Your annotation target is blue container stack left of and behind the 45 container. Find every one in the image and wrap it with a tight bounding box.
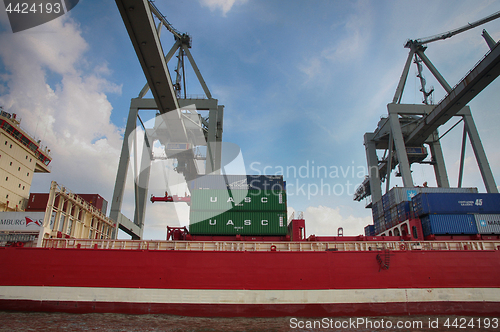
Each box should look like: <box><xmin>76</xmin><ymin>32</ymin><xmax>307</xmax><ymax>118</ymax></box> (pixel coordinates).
<box><xmin>372</xmin><ymin>187</ymin><xmax>477</xmax><ymax>234</ymax></box>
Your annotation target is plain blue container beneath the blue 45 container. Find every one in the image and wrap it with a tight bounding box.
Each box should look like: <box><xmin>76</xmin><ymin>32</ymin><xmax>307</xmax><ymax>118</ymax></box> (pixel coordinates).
<box><xmin>421</xmin><ymin>214</ymin><xmax>478</xmax><ymax>236</ymax></box>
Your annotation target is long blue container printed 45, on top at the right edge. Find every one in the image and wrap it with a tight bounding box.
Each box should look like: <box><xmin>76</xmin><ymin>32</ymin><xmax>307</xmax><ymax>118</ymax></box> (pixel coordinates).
<box><xmin>412</xmin><ymin>193</ymin><xmax>500</xmax><ymax>216</ymax></box>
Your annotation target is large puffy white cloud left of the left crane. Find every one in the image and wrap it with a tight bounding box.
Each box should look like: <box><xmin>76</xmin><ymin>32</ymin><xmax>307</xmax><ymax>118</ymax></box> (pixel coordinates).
<box><xmin>0</xmin><ymin>15</ymin><xmax>121</xmax><ymax>197</ymax></box>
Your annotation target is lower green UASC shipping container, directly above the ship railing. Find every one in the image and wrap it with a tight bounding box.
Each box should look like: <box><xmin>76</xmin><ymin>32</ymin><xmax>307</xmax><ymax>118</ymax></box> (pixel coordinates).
<box><xmin>189</xmin><ymin>210</ymin><xmax>288</xmax><ymax>235</ymax></box>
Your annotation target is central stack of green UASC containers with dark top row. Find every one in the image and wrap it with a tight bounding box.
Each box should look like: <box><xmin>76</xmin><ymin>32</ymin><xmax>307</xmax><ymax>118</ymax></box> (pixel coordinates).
<box><xmin>189</xmin><ymin>175</ymin><xmax>288</xmax><ymax>236</ymax></box>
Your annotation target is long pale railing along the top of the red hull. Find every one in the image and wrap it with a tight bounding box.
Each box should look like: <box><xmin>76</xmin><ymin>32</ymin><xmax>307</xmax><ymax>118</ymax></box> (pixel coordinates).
<box><xmin>42</xmin><ymin>238</ymin><xmax>500</xmax><ymax>252</ymax></box>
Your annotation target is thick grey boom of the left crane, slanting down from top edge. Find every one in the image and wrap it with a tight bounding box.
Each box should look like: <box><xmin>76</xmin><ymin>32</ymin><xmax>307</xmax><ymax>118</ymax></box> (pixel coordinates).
<box><xmin>116</xmin><ymin>0</ymin><xmax>179</xmax><ymax>113</ymax></box>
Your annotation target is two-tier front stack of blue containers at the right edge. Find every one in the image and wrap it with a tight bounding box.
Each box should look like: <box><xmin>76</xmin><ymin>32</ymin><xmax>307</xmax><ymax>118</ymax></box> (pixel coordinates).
<box><xmin>412</xmin><ymin>193</ymin><xmax>500</xmax><ymax>236</ymax></box>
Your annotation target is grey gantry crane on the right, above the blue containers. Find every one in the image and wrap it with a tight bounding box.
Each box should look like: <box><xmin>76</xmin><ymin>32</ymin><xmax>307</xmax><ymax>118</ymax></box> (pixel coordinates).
<box><xmin>354</xmin><ymin>12</ymin><xmax>500</xmax><ymax>207</ymax></box>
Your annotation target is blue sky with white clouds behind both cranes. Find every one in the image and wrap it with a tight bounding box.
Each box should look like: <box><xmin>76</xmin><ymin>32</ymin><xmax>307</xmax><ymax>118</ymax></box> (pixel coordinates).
<box><xmin>0</xmin><ymin>0</ymin><xmax>500</xmax><ymax>239</ymax></box>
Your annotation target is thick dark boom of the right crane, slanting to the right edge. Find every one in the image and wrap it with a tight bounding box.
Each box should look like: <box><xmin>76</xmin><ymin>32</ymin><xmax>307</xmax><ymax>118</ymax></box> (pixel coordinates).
<box><xmin>406</xmin><ymin>45</ymin><xmax>500</xmax><ymax>144</ymax></box>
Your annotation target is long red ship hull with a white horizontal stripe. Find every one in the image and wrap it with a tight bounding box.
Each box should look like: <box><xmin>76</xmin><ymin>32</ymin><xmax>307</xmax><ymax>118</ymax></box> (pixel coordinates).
<box><xmin>0</xmin><ymin>248</ymin><xmax>500</xmax><ymax>317</ymax></box>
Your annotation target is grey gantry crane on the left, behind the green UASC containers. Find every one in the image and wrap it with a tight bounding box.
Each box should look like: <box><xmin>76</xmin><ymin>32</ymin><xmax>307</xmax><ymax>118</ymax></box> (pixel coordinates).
<box><xmin>110</xmin><ymin>0</ymin><xmax>224</xmax><ymax>239</ymax></box>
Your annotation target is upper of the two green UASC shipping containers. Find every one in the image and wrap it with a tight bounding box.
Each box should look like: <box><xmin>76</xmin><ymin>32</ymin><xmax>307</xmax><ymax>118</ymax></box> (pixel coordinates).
<box><xmin>191</xmin><ymin>189</ymin><xmax>286</xmax><ymax>212</ymax></box>
